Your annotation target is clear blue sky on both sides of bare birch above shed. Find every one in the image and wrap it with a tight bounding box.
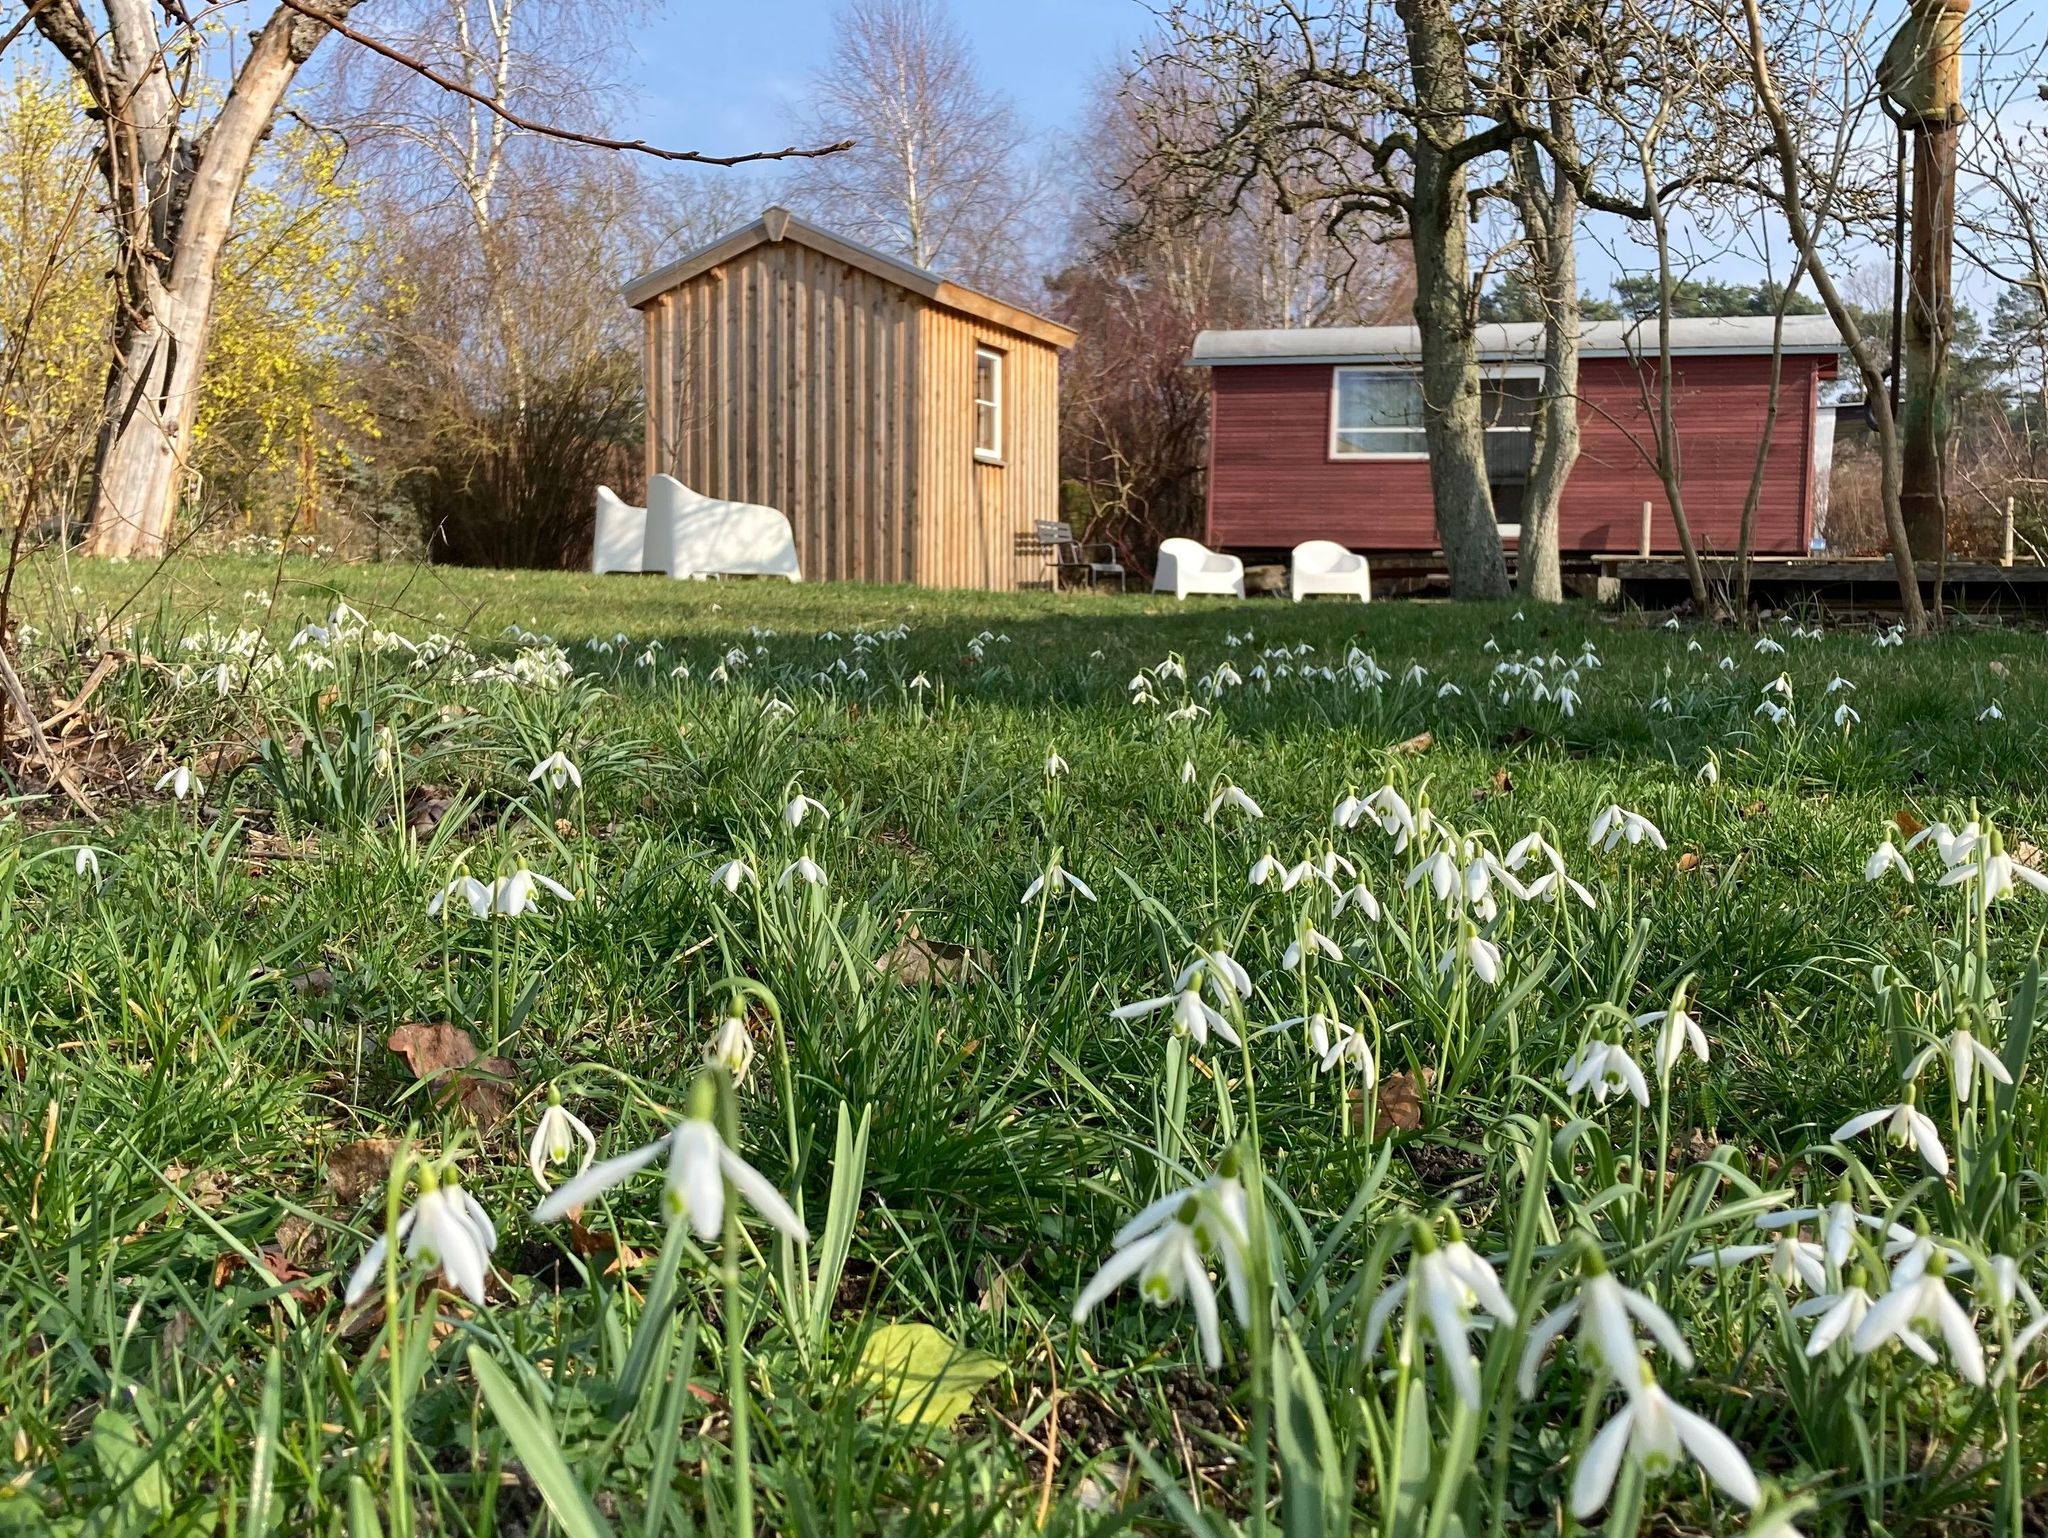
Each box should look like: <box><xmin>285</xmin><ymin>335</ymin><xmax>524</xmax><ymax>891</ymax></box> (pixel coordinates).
<box><xmin>631</xmin><ymin>0</ymin><xmax>1149</xmax><ymax>165</ymax></box>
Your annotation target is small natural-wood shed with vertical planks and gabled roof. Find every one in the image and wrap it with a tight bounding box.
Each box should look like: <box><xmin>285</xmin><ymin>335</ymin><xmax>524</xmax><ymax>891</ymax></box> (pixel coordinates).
<box><xmin>627</xmin><ymin>209</ymin><xmax>1075</xmax><ymax>588</ymax></box>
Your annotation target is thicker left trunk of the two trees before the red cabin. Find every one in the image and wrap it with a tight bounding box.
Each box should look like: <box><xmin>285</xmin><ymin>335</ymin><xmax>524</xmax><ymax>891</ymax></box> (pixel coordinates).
<box><xmin>1399</xmin><ymin>0</ymin><xmax>1507</xmax><ymax>598</ymax></box>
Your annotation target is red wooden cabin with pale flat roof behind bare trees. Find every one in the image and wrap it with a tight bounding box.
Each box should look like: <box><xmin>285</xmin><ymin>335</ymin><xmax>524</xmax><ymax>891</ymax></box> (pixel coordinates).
<box><xmin>1190</xmin><ymin>315</ymin><xmax>1841</xmax><ymax>557</ymax></box>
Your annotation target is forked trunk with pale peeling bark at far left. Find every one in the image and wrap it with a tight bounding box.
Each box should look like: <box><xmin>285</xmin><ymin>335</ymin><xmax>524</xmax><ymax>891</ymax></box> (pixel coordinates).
<box><xmin>35</xmin><ymin>0</ymin><xmax>356</xmax><ymax>557</ymax></box>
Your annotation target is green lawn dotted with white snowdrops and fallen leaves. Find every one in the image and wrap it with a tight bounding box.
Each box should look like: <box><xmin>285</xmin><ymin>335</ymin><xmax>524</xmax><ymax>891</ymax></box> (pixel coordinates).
<box><xmin>0</xmin><ymin>559</ymin><xmax>2048</xmax><ymax>1538</ymax></box>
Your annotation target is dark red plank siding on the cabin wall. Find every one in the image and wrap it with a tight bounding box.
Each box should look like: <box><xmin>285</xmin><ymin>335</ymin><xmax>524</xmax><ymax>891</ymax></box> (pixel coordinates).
<box><xmin>1208</xmin><ymin>354</ymin><xmax>1833</xmax><ymax>555</ymax></box>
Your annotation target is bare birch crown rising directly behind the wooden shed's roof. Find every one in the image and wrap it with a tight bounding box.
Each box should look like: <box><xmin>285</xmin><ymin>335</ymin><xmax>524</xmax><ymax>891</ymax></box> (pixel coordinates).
<box><xmin>793</xmin><ymin>0</ymin><xmax>1040</xmax><ymax>295</ymax></box>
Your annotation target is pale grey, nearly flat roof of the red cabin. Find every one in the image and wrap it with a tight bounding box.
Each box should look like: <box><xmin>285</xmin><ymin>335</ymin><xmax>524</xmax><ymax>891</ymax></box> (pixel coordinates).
<box><xmin>1188</xmin><ymin>315</ymin><xmax>1841</xmax><ymax>367</ymax></box>
